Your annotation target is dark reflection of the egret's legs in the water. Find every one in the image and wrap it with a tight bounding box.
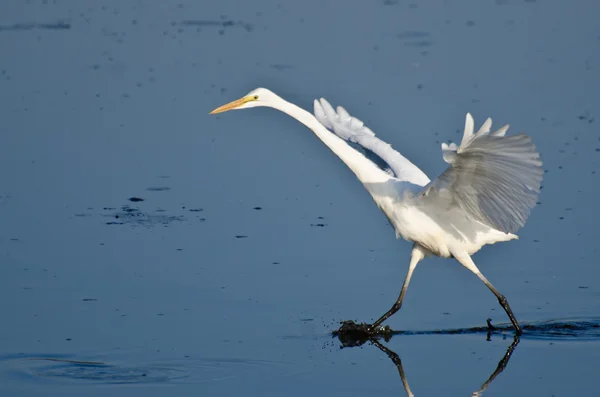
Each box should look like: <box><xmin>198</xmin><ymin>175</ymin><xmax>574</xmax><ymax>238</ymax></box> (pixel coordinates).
<box><xmin>337</xmin><ymin>330</ymin><xmax>519</xmax><ymax>397</ymax></box>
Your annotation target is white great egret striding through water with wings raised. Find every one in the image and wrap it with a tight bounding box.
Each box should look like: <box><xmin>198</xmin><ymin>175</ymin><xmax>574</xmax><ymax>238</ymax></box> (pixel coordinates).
<box><xmin>210</xmin><ymin>88</ymin><xmax>543</xmax><ymax>334</ymax></box>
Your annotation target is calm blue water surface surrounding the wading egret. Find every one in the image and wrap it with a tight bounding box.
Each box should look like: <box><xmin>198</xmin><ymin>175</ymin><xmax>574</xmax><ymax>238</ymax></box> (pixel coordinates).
<box><xmin>0</xmin><ymin>0</ymin><xmax>600</xmax><ymax>396</ymax></box>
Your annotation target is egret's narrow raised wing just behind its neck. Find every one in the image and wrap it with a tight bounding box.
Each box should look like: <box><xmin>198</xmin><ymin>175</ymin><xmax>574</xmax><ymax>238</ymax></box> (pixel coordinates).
<box><xmin>314</xmin><ymin>98</ymin><xmax>429</xmax><ymax>186</ymax></box>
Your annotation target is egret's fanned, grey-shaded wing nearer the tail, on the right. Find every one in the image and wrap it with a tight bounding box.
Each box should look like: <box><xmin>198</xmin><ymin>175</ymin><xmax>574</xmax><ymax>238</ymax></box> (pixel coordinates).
<box><xmin>421</xmin><ymin>113</ymin><xmax>543</xmax><ymax>233</ymax></box>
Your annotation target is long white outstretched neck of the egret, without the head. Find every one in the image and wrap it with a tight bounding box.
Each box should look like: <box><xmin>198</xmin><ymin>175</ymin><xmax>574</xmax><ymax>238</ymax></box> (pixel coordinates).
<box><xmin>269</xmin><ymin>98</ymin><xmax>391</xmax><ymax>184</ymax></box>
